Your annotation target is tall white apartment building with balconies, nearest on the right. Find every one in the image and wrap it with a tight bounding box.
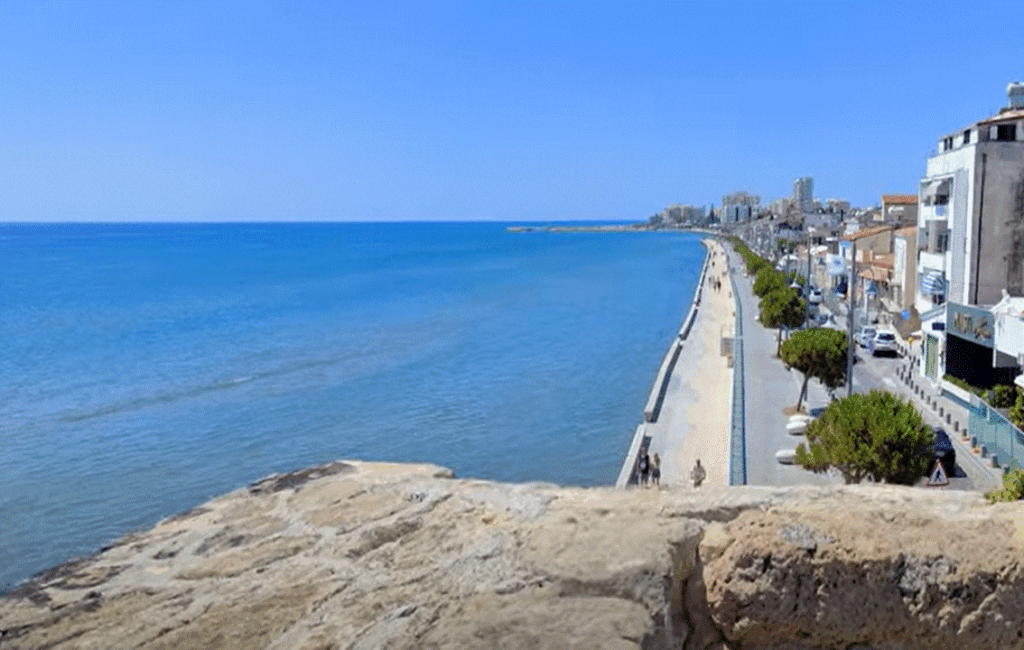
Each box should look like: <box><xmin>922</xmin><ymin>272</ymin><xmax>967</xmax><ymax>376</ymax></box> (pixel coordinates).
<box><xmin>914</xmin><ymin>84</ymin><xmax>1024</xmax><ymax>313</ymax></box>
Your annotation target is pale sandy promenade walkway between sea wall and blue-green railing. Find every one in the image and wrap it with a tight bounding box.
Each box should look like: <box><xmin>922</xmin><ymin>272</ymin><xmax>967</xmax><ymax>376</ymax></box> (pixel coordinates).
<box><xmin>630</xmin><ymin>239</ymin><xmax>735</xmax><ymax>486</ymax></box>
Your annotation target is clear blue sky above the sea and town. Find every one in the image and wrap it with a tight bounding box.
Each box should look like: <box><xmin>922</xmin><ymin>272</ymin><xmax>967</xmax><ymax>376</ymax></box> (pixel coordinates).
<box><xmin>0</xmin><ymin>0</ymin><xmax>1024</xmax><ymax>221</ymax></box>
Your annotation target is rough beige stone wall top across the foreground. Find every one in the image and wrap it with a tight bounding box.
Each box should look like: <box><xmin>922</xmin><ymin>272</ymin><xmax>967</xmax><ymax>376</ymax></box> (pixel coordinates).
<box><xmin>0</xmin><ymin>462</ymin><xmax>1024</xmax><ymax>650</ymax></box>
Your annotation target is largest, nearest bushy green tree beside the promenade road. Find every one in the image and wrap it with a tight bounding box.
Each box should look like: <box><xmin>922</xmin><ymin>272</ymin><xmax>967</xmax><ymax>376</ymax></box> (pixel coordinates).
<box><xmin>797</xmin><ymin>390</ymin><xmax>935</xmax><ymax>485</ymax></box>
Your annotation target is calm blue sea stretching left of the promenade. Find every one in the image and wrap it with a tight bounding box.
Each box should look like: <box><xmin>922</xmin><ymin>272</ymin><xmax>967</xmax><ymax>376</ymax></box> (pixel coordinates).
<box><xmin>0</xmin><ymin>222</ymin><xmax>705</xmax><ymax>588</ymax></box>
